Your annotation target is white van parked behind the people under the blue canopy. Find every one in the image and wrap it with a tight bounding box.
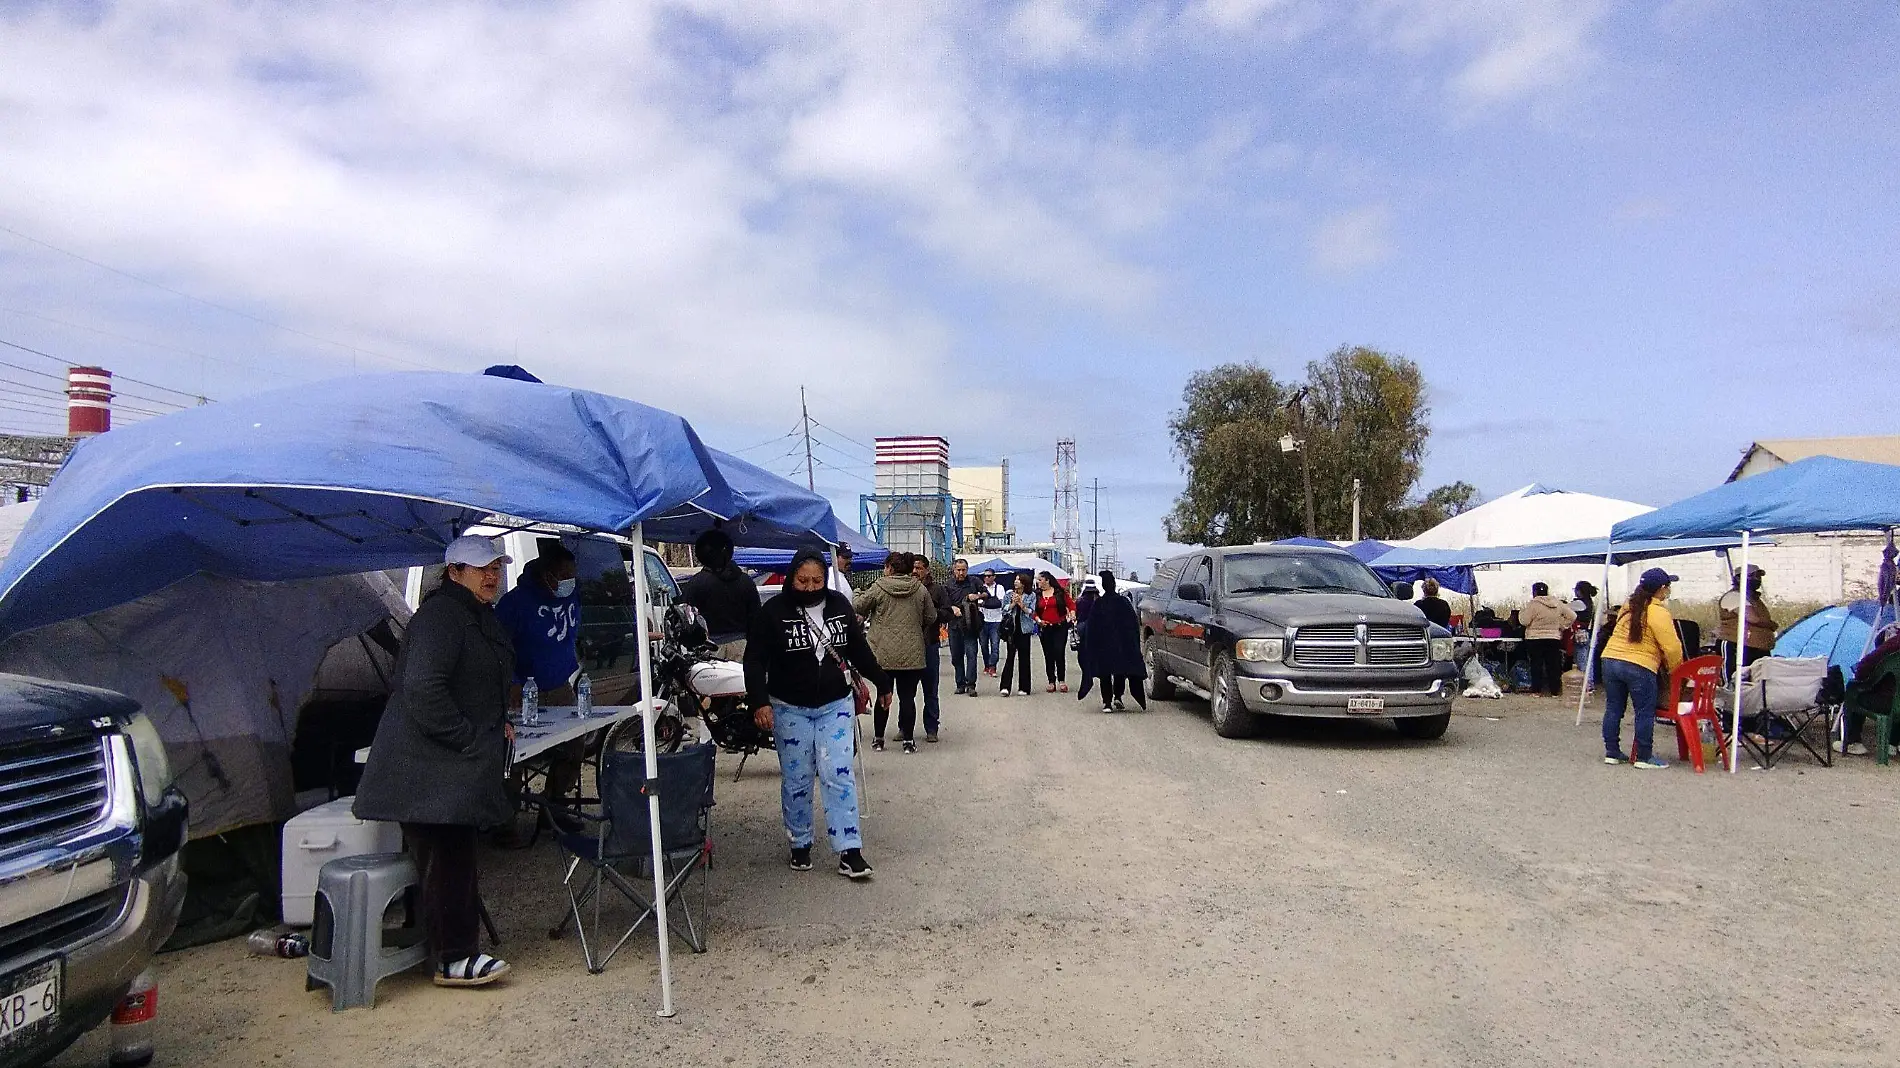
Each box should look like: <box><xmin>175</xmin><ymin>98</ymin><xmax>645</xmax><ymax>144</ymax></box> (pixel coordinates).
<box><xmin>403</xmin><ymin>526</ymin><xmax>680</xmax><ymax>705</ymax></box>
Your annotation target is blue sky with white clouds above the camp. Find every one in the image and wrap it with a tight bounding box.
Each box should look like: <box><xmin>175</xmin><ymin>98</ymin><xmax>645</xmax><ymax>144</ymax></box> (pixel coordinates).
<box><xmin>0</xmin><ymin>0</ymin><xmax>1900</xmax><ymax>574</ymax></box>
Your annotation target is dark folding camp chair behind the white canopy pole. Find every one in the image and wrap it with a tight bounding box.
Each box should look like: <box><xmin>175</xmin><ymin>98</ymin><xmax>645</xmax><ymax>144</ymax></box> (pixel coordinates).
<box><xmin>547</xmin><ymin>743</ymin><xmax>718</xmax><ymax>975</ymax></box>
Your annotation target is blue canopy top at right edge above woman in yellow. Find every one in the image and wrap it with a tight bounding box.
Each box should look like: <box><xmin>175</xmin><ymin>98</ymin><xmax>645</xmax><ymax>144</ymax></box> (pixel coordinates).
<box><xmin>1609</xmin><ymin>456</ymin><xmax>1900</xmax><ymax>544</ymax></box>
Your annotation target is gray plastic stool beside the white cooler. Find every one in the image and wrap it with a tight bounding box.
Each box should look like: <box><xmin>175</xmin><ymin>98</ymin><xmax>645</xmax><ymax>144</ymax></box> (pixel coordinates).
<box><xmin>304</xmin><ymin>853</ymin><xmax>429</xmax><ymax>1013</ymax></box>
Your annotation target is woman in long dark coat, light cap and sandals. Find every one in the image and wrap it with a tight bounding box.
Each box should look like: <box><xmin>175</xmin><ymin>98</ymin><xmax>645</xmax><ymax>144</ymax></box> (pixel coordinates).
<box><xmin>353</xmin><ymin>534</ymin><xmax>515</xmax><ymax>986</ymax></box>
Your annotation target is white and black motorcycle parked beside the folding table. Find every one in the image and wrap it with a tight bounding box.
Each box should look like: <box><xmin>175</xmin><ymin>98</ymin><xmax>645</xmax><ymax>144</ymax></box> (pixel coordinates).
<box><xmin>602</xmin><ymin>604</ymin><xmax>775</xmax><ymax>779</ymax></box>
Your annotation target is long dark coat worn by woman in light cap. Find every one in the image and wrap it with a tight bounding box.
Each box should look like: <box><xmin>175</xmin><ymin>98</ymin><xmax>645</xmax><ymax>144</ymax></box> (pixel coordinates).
<box><xmin>352</xmin><ymin>583</ymin><xmax>515</xmax><ymax>827</ymax></box>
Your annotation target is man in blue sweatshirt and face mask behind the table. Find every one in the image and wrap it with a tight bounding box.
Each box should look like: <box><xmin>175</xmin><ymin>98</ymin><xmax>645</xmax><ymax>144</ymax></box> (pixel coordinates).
<box><xmin>494</xmin><ymin>540</ymin><xmax>587</xmax><ymax>824</ymax></box>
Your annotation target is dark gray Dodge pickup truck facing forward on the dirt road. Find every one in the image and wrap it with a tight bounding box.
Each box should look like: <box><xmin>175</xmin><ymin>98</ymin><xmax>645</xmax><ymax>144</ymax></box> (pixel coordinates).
<box><xmin>1140</xmin><ymin>545</ymin><xmax>1457</xmax><ymax>739</ymax></box>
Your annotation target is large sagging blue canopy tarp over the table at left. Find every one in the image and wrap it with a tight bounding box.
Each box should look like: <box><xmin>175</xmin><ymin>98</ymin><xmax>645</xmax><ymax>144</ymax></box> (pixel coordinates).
<box><xmin>0</xmin><ymin>372</ymin><xmax>830</xmax><ymax>635</ymax></box>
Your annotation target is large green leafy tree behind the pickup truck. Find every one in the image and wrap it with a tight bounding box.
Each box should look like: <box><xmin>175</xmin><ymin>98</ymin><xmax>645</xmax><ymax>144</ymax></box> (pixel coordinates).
<box><xmin>1165</xmin><ymin>346</ymin><xmax>1476</xmax><ymax>545</ymax></box>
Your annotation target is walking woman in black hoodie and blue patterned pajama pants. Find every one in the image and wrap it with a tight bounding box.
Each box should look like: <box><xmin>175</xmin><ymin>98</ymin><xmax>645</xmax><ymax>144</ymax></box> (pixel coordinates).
<box><xmin>745</xmin><ymin>549</ymin><xmax>891</xmax><ymax>880</ymax></box>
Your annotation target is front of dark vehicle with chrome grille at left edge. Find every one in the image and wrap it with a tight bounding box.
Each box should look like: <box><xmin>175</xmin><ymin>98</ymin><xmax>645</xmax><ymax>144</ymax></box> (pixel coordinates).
<box><xmin>0</xmin><ymin>675</ymin><xmax>184</xmax><ymax>1066</ymax></box>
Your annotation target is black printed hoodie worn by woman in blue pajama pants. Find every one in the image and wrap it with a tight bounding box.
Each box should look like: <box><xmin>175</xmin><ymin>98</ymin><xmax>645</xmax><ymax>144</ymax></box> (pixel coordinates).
<box><xmin>745</xmin><ymin>589</ymin><xmax>891</xmax><ymax>709</ymax></box>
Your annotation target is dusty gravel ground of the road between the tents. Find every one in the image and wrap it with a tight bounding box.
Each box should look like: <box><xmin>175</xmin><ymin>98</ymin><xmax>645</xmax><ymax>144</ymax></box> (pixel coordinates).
<box><xmin>59</xmin><ymin>686</ymin><xmax>1900</xmax><ymax>1068</ymax></box>
